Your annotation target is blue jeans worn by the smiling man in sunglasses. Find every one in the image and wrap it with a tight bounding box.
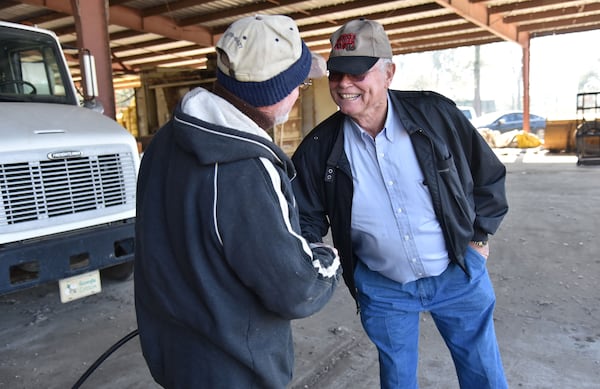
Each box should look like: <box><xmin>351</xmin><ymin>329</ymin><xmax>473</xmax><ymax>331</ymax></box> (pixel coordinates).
<box><xmin>354</xmin><ymin>247</ymin><xmax>508</xmax><ymax>389</ymax></box>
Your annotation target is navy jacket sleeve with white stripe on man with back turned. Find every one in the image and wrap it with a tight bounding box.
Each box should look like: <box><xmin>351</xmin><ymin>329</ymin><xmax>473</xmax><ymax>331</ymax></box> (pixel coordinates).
<box><xmin>215</xmin><ymin>158</ymin><xmax>341</xmax><ymax>319</ymax></box>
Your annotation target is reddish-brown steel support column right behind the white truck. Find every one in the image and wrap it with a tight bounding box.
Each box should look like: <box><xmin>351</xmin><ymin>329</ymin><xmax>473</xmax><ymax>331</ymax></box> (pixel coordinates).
<box><xmin>71</xmin><ymin>0</ymin><xmax>116</xmax><ymax>119</ymax></box>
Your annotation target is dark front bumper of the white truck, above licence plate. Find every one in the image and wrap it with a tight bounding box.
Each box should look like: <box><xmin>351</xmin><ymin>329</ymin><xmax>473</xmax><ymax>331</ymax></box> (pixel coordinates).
<box><xmin>0</xmin><ymin>218</ymin><xmax>135</xmax><ymax>295</ymax></box>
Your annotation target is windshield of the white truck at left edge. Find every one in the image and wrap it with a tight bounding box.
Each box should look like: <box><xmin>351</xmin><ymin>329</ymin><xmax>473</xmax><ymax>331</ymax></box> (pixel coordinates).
<box><xmin>0</xmin><ymin>27</ymin><xmax>76</xmax><ymax>104</ymax></box>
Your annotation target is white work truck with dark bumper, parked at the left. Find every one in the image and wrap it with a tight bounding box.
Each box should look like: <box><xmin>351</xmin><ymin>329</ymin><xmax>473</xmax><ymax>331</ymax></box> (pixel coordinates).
<box><xmin>0</xmin><ymin>22</ymin><xmax>139</xmax><ymax>302</ymax></box>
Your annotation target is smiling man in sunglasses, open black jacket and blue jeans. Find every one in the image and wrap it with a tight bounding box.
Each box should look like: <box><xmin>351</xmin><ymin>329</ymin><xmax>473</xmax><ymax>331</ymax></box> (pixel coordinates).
<box><xmin>292</xmin><ymin>19</ymin><xmax>508</xmax><ymax>389</ymax></box>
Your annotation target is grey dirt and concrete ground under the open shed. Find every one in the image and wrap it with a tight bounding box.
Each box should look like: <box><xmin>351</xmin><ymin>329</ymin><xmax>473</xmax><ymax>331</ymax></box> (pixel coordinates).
<box><xmin>0</xmin><ymin>149</ymin><xmax>600</xmax><ymax>389</ymax></box>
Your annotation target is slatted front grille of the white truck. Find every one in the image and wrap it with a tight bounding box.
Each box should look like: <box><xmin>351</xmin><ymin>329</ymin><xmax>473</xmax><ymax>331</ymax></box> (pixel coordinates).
<box><xmin>0</xmin><ymin>153</ymin><xmax>136</xmax><ymax>226</ymax></box>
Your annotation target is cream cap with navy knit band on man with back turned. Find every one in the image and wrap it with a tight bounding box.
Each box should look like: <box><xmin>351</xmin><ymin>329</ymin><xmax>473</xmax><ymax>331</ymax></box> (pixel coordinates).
<box><xmin>216</xmin><ymin>15</ymin><xmax>312</xmax><ymax>107</ymax></box>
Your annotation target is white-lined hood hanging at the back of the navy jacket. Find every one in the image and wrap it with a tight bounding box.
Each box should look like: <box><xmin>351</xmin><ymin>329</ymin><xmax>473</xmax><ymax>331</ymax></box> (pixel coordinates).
<box><xmin>173</xmin><ymin>88</ymin><xmax>295</xmax><ymax>178</ymax></box>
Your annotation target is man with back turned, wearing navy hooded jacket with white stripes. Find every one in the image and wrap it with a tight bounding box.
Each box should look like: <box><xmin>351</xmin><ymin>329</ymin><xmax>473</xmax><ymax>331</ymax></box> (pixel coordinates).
<box><xmin>134</xmin><ymin>15</ymin><xmax>341</xmax><ymax>389</ymax></box>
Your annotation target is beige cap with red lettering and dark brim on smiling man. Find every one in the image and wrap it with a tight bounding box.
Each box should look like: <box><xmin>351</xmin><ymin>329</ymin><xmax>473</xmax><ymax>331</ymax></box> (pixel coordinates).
<box><xmin>327</xmin><ymin>18</ymin><xmax>393</xmax><ymax>74</ymax></box>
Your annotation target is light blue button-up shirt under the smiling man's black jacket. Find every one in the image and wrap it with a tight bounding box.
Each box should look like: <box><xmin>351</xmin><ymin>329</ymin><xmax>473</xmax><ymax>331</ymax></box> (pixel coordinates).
<box><xmin>344</xmin><ymin>98</ymin><xmax>449</xmax><ymax>284</ymax></box>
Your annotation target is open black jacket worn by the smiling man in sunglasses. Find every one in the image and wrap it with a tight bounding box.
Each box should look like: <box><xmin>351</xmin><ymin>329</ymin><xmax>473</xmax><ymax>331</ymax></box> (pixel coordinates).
<box><xmin>292</xmin><ymin>90</ymin><xmax>508</xmax><ymax>297</ymax></box>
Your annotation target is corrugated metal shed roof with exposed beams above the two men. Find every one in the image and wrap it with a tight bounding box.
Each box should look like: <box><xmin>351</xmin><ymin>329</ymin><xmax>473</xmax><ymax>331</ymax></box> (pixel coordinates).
<box><xmin>0</xmin><ymin>0</ymin><xmax>600</xmax><ymax>87</ymax></box>
